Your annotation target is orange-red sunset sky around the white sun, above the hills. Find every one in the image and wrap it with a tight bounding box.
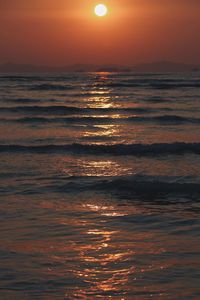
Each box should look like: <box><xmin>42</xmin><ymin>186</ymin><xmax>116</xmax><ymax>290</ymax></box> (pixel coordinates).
<box><xmin>0</xmin><ymin>0</ymin><xmax>200</xmax><ymax>66</ymax></box>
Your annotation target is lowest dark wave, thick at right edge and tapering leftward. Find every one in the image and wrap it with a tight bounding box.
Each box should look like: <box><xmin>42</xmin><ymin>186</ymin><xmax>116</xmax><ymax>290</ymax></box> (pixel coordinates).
<box><xmin>56</xmin><ymin>175</ymin><xmax>200</xmax><ymax>196</ymax></box>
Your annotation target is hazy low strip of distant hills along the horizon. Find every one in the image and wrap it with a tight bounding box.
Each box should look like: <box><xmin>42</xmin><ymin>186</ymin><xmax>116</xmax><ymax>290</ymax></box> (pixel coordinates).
<box><xmin>0</xmin><ymin>61</ymin><xmax>200</xmax><ymax>73</ymax></box>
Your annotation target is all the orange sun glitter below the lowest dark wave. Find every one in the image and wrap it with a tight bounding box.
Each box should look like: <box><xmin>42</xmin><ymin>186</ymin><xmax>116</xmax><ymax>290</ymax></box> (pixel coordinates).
<box><xmin>66</xmin><ymin>203</ymin><xmax>167</xmax><ymax>299</ymax></box>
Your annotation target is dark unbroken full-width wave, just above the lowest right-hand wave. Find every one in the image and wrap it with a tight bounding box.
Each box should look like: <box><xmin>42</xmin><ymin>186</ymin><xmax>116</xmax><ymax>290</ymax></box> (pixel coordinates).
<box><xmin>0</xmin><ymin>142</ymin><xmax>200</xmax><ymax>156</ymax></box>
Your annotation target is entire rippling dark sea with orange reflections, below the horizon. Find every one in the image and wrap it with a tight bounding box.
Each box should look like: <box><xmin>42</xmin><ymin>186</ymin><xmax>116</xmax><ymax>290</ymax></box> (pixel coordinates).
<box><xmin>0</xmin><ymin>72</ymin><xmax>200</xmax><ymax>300</ymax></box>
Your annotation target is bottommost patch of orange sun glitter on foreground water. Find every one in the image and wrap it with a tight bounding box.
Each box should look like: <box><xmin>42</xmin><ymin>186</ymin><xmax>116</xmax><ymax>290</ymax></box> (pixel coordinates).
<box><xmin>70</xmin><ymin>224</ymin><xmax>134</xmax><ymax>297</ymax></box>
